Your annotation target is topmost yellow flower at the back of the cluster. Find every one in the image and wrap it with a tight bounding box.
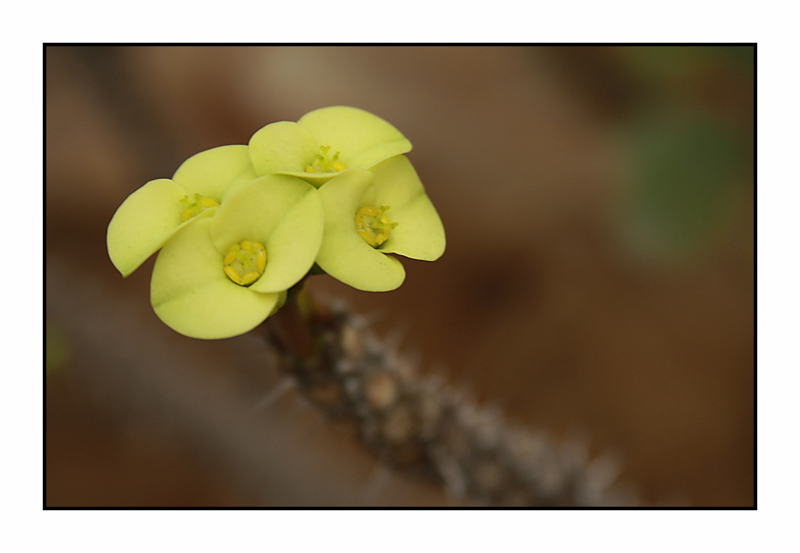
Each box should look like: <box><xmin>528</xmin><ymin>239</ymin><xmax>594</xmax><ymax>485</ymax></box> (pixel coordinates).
<box><xmin>249</xmin><ymin>106</ymin><xmax>411</xmax><ymax>187</ymax></box>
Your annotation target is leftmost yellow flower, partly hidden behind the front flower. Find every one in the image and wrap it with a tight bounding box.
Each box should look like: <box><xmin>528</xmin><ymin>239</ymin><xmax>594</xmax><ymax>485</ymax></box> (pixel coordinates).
<box><xmin>106</xmin><ymin>145</ymin><xmax>258</xmax><ymax>276</ymax></box>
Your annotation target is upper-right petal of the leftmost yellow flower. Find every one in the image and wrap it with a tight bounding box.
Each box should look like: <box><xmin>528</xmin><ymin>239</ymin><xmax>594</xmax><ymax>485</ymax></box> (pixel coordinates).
<box><xmin>172</xmin><ymin>145</ymin><xmax>258</xmax><ymax>203</ymax></box>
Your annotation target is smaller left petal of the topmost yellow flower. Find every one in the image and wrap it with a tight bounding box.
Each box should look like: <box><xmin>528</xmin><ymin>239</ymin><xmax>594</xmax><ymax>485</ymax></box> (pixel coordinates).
<box><xmin>249</xmin><ymin>121</ymin><xmax>320</xmax><ymax>178</ymax></box>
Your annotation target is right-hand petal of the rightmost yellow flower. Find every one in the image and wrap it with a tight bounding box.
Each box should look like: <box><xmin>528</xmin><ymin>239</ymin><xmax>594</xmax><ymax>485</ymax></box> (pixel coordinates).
<box><xmin>364</xmin><ymin>156</ymin><xmax>445</xmax><ymax>261</ymax></box>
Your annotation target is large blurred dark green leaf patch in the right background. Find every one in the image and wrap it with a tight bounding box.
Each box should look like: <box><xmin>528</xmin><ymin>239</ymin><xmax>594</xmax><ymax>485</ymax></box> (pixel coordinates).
<box><xmin>622</xmin><ymin>116</ymin><xmax>747</xmax><ymax>259</ymax></box>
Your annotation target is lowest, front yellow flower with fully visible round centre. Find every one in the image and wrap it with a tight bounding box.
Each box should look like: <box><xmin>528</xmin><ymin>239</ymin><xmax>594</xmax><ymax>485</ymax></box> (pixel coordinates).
<box><xmin>150</xmin><ymin>175</ymin><xmax>323</xmax><ymax>339</ymax></box>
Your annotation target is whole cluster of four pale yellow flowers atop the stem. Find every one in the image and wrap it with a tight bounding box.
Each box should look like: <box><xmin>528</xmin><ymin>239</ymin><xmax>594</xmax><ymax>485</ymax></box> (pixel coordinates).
<box><xmin>107</xmin><ymin>106</ymin><xmax>445</xmax><ymax>339</ymax></box>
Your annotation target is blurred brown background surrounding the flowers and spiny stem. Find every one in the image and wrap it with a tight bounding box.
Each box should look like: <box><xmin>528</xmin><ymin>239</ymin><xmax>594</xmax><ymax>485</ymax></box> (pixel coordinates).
<box><xmin>45</xmin><ymin>46</ymin><xmax>755</xmax><ymax>506</ymax></box>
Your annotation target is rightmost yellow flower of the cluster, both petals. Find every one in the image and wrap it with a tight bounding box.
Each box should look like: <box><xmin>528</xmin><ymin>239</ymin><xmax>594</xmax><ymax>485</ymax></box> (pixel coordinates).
<box><xmin>317</xmin><ymin>155</ymin><xmax>445</xmax><ymax>292</ymax></box>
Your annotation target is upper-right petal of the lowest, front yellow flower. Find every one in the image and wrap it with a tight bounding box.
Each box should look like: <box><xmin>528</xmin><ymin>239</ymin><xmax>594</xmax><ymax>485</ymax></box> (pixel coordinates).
<box><xmin>211</xmin><ymin>175</ymin><xmax>323</xmax><ymax>292</ymax></box>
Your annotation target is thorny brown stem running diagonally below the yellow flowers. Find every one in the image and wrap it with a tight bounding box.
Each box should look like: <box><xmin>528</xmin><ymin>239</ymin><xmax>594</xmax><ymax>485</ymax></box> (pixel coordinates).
<box><xmin>267</xmin><ymin>291</ymin><xmax>634</xmax><ymax>506</ymax></box>
